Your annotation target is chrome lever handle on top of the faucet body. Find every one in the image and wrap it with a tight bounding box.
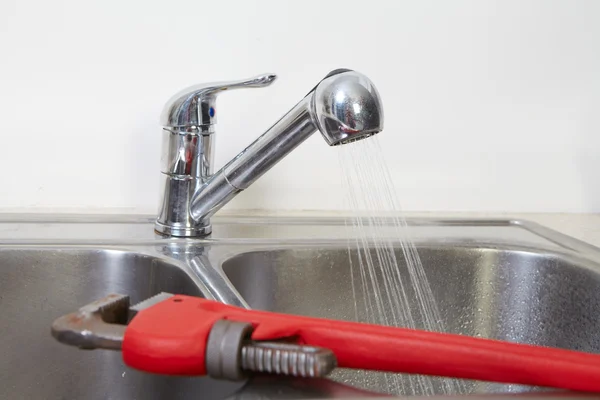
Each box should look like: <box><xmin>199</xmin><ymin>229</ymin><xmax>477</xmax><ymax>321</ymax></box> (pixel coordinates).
<box><xmin>160</xmin><ymin>74</ymin><xmax>277</xmax><ymax>129</ymax></box>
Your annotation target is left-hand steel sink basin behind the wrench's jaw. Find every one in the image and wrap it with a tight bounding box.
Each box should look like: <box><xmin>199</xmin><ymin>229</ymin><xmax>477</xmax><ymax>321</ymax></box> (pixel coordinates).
<box><xmin>0</xmin><ymin>247</ymin><xmax>240</xmax><ymax>399</ymax></box>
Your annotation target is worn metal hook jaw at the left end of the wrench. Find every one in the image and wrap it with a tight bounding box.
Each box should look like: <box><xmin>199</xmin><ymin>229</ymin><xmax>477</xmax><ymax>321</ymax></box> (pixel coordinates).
<box><xmin>52</xmin><ymin>294</ymin><xmax>129</xmax><ymax>350</ymax></box>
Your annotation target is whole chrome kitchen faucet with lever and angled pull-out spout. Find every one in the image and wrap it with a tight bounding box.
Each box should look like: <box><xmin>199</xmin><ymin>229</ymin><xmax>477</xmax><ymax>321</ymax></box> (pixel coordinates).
<box><xmin>155</xmin><ymin>69</ymin><xmax>383</xmax><ymax>237</ymax></box>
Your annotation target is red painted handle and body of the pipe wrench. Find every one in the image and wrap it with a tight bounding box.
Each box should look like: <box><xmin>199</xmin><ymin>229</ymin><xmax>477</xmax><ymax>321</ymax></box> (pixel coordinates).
<box><xmin>123</xmin><ymin>295</ymin><xmax>600</xmax><ymax>392</ymax></box>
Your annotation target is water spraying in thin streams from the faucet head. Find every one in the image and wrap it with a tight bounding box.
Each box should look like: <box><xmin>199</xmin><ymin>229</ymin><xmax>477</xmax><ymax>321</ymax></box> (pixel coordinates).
<box><xmin>338</xmin><ymin>136</ymin><xmax>465</xmax><ymax>395</ymax></box>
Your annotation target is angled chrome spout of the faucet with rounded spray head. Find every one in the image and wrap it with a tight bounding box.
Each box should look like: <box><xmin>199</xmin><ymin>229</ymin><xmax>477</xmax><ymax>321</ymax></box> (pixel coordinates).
<box><xmin>190</xmin><ymin>70</ymin><xmax>383</xmax><ymax>220</ymax></box>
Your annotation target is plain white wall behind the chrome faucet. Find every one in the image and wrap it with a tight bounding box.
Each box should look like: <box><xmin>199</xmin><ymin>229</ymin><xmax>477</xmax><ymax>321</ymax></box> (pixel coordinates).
<box><xmin>0</xmin><ymin>0</ymin><xmax>600</xmax><ymax>213</ymax></box>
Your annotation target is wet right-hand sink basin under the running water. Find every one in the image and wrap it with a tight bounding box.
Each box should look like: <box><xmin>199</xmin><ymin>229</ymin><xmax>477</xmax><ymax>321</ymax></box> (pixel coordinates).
<box><xmin>222</xmin><ymin>244</ymin><xmax>600</xmax><ymax>394</ymax></box>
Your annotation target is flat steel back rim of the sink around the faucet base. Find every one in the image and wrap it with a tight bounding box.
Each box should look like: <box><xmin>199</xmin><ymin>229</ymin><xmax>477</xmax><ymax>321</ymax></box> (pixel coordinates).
<box><xmin>0</xmin><ymin>213</ymin><xmax>600</xmax><ymax>260</ymax></box>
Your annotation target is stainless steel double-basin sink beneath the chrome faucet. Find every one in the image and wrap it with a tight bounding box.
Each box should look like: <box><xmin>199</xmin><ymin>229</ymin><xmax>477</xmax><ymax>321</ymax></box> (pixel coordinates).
<box><xmin>0</xmin><ymin>216</ymin><xmax>600</xmax><ymax>399</ymax></box>
